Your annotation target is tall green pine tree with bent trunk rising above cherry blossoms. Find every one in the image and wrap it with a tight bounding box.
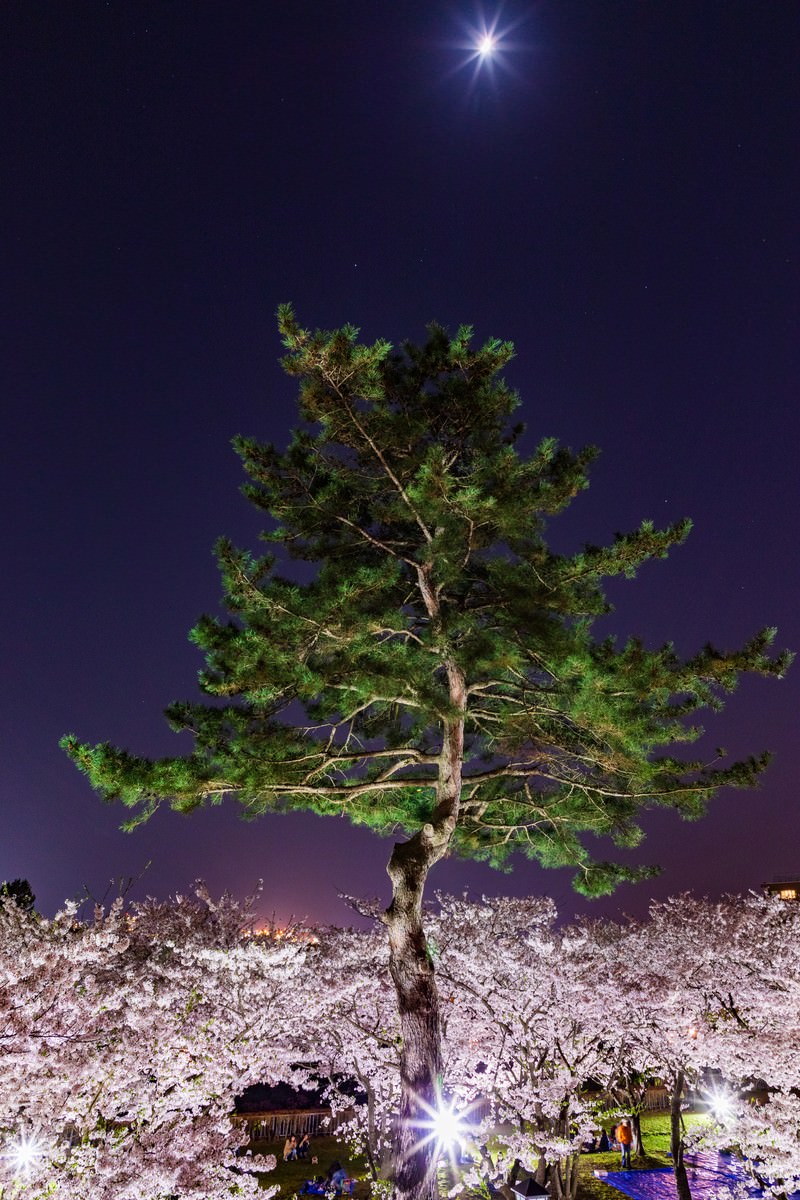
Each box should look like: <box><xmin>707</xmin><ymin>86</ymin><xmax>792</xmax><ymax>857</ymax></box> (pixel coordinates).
<box><xmin>64</xmin><ymin>306</ymin><xmax>788</xmax><ymax>1200</ymax></box>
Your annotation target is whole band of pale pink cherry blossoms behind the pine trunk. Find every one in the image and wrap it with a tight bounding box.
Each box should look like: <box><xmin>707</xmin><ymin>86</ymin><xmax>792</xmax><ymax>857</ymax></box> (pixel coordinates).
<box><xmin>0</xmin><ymin>889</ymin><xmax>800</xmax><ymax>1200</ymax></box>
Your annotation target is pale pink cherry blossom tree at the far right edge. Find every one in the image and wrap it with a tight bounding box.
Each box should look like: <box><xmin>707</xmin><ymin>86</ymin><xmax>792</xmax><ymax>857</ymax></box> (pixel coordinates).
<box><xmin>575</xmin><ymin>895</ymin><xmax>800</xmax><ymax>1200</ymax></box>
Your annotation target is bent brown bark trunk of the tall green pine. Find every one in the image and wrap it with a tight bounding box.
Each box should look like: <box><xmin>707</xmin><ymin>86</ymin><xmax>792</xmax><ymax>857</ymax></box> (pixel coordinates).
<box><xmin>384</xmin><ymin>667</ymin><xmax>465</xmax><ymax>1200</ymax></box>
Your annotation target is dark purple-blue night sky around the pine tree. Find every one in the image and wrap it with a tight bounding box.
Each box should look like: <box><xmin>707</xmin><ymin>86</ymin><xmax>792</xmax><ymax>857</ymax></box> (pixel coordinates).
<box><xmin>0</xmin><ymin>0</ymin><xmax>800</xmax><ymax>923</ymax></box>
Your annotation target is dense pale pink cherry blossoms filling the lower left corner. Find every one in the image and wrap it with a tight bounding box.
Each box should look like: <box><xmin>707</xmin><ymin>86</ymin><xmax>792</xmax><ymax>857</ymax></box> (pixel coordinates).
<box><xmin>0</xmin><ymin>889</ymin><xmax>305</xmax><ymax>1200</ymax></box>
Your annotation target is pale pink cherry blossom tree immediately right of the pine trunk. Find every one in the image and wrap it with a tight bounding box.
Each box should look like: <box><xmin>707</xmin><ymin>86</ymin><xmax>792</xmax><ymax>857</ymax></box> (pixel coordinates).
<box><xmin>433</xmin><ymin>898</ymin><xmax>601</xmax><ymax>1200</ymax></box>
